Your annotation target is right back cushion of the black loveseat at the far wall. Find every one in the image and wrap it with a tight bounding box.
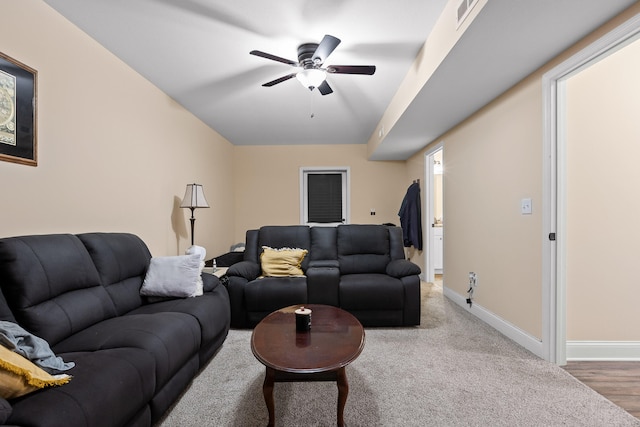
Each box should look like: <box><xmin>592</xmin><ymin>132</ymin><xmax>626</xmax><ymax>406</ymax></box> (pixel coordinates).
<box><xmin>337</xmin><ymin>225</ymin><xmax>391</xmax><ymax>274</ymax></box>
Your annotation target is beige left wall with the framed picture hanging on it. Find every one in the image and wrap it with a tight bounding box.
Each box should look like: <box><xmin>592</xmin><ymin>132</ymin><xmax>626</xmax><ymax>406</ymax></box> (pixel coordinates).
<box><xmin>0</xmin><ymin>0</ymin><xmax>234</xmax><ymax>255</ymax></box>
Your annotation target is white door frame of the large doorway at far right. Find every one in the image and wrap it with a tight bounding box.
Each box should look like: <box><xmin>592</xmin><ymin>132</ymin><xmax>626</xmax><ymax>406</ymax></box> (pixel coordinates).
<box><xmin>542</xmin><ymin>15</ymin><xmax>640</xmax><ymax>365</ymax></box>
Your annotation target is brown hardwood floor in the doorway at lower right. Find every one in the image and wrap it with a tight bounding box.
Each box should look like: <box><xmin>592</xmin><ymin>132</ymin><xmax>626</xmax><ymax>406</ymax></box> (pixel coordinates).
<box><xmin>564</xmin><ymin>361</ymin><xmax>640</xmax><ymax>419</ymax></box>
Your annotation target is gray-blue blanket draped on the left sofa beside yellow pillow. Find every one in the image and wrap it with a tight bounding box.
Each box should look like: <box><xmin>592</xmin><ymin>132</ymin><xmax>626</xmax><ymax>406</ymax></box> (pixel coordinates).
<box><xmin>0</xmin><ymin>321</ymin><xmax>75</xmax><ymax>374</ymax></box>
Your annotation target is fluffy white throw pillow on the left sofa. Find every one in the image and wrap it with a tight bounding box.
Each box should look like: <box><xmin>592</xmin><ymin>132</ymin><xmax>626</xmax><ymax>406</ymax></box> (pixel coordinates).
<box><xmin>140</xmin><ymin>254</ymin><xmax>202</xmax><ymax>298</ymax></box>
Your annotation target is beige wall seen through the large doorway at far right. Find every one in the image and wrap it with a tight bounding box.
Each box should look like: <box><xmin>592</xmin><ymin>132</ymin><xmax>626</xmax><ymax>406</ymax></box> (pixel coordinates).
<box><xmin>566</xmin><ymin>36</ymin><xmax>640</xmax><ymax>341</ymax></box>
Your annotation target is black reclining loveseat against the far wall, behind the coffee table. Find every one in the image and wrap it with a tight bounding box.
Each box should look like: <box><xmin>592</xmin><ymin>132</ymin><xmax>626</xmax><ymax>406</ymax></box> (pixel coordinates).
<box><xmin>227</xmin><ymin>225</ymin><xmax>420</xmax><ymax>328</ymax></box>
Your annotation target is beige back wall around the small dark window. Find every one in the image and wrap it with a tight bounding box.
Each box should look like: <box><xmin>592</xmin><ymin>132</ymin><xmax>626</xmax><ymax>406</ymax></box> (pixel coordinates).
<box><xmin>233</xmin><ymin>144</ymin><xmax>408</xmax><ymax>242</ymax></box>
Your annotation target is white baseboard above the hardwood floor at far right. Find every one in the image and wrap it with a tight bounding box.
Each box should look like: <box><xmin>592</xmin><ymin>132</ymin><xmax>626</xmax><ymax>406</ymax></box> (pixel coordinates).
<box><xmin>567</xmin><ymin>341</ymin><xmax>640</xmax><ymax>361</ymax></box>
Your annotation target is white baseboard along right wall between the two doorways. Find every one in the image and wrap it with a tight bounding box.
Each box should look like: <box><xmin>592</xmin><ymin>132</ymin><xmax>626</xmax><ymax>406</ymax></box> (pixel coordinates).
<box><xmin>442</xmin><ymin>286</ymin><xmax>544</xmax><ymax>359</ymax></box>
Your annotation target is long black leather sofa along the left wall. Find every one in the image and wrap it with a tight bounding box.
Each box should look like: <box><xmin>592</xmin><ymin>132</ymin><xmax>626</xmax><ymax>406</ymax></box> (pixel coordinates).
<box><xmin>0</xmin><ymin>233</ymin><xmax>230</xmax><ymax>427</ymax></box>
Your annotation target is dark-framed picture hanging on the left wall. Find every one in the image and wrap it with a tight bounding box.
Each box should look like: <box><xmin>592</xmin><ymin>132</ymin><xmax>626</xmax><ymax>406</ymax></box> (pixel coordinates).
<box><xmin>0</xmin><ymin>53</ymin><xmax>38</xmax><ymax>166</ymax></box>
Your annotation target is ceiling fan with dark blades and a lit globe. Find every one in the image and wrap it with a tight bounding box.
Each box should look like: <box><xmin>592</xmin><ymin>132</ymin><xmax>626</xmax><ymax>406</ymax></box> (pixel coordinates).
<box><xmin>249</xmin><ymin>34</ymin><xmax>376</xmax><ymax>95</ymax></box>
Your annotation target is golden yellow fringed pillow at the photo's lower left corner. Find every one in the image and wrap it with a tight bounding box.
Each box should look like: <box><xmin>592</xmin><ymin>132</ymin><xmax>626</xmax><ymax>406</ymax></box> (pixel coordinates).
<box><xmin>0</xmin><ymin>345</ymin><xmax>71</xmax><ymax>399</ymax></box>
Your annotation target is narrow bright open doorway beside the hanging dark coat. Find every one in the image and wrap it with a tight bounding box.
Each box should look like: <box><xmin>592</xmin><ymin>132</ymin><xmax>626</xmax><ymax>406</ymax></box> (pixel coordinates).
<box><xmin>424</xmin><ymin>142</ymin><xmax>444</xmax><ymax>284</ymax></box>
